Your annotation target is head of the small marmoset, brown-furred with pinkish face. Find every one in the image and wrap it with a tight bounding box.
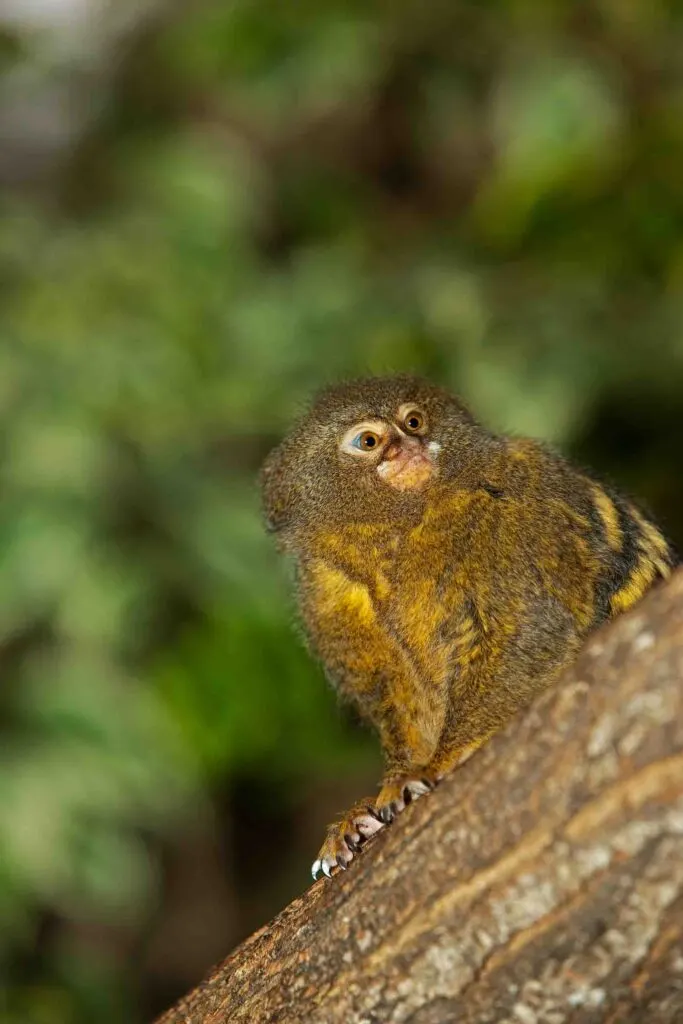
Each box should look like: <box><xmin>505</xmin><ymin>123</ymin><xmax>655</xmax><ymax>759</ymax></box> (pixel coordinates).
<box><xmin>262</xmin><ymin>375</ymin><xmax>478</xmax><ymax>531</ymax></box>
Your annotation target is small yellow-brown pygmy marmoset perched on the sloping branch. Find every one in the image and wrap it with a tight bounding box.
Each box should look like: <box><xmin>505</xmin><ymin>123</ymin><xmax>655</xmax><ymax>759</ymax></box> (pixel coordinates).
<box><xmin>262</xmin><ymin>376</ymin><xmax>674</xmax><ymax>878</ymax></box>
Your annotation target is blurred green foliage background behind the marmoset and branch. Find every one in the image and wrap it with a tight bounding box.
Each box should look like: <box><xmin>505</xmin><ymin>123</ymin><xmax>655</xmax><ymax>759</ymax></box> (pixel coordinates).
<box><xmin>0</xmin><ymin>0</ymin><xmax>683</xmax><ymax>1024</ymax></box>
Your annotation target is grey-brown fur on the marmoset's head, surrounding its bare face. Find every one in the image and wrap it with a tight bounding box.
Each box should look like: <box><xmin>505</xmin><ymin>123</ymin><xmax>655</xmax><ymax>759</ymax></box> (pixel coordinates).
<box><xmin>261</xmin><ymin>374</ymin><xmax>485</xmax><ymax>535</ymax></box>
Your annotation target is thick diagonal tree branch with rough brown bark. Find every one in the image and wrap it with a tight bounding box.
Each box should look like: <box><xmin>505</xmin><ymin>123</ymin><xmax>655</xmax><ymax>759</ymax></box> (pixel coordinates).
<box><xmin>160</xmin><ymin>570</ymin><xmax>683</xmax><ymax>1024</ymax></box>
